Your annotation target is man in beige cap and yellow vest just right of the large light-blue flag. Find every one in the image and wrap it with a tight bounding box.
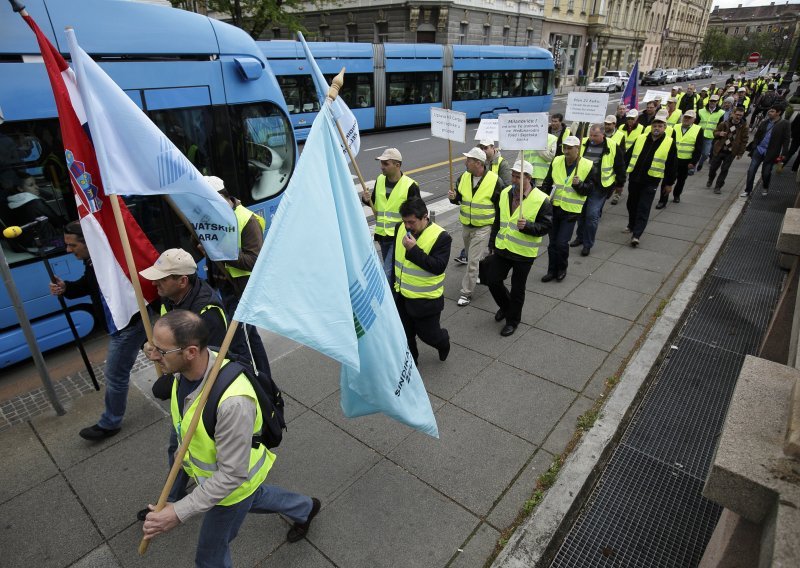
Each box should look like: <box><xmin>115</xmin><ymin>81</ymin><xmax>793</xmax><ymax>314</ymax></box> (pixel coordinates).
<box><xmin>361</xmin><ymin>148</ymin><xmax>420</xmax><ymax>282</ymax></box>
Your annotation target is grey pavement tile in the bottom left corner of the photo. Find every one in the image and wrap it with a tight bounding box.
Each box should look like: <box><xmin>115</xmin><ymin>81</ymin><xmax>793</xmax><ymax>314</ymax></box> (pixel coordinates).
<box><xmin>0</xmin><ymin>475</ymin><xmax>103</xmax><ymax>568</ymax></box>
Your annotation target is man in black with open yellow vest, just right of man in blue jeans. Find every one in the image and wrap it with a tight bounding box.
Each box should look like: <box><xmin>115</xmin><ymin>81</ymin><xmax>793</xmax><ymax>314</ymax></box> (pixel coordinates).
<box><xmin>623</xmin><ymin>111</ymin><xmax>677</xmax><ymax>247</ymax></box>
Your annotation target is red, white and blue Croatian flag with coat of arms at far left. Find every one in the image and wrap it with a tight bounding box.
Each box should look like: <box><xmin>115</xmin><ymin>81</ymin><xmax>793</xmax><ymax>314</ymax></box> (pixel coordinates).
<box><xmin>23</xmin><ymin>15</ymin><xmax>158</xmax><ymax>331</ymax></box>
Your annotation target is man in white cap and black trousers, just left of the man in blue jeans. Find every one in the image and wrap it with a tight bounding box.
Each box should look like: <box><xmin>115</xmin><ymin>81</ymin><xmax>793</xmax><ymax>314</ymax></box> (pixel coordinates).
<box><xmin>542</xmin><ymin>136</ymin><xmax>600</xmax><ymax>282</ymax></box>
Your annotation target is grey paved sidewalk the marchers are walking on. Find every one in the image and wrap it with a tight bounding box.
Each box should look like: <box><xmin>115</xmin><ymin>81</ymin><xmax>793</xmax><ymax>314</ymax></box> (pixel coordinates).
<box><xmin>0</xmin><ymin>156</ymin><xmax>747</xmax><ymax>568</ymax></box>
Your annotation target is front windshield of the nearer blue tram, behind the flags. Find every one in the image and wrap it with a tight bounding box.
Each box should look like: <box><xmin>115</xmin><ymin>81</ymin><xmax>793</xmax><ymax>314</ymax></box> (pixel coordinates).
<box><xmin>231</xmin><ymin>103</ymin><xmax>295</xmax><ymax>205</ymax></box>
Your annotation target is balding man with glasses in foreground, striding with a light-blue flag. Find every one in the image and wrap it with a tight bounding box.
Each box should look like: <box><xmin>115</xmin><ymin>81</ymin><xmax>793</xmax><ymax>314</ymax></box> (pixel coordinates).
<box><xmin>143</xmin><ymin>310</ymin><xmax>320</xmax><ymax>568</ymax></box>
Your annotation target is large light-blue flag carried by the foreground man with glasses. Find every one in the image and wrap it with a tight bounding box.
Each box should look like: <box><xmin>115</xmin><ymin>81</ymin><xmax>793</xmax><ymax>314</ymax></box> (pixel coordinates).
<box><xmin>234</xmin><ymin>104</ymin><xmax>439</xmax><ymax>438</ymax></box>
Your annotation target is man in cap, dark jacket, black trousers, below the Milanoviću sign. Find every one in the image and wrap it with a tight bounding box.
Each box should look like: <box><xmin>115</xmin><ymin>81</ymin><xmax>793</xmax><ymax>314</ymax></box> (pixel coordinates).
<box><xmin>481</xmin><ymin>161</ymin><xmax>553</xmax><ymax>337</ymax></box>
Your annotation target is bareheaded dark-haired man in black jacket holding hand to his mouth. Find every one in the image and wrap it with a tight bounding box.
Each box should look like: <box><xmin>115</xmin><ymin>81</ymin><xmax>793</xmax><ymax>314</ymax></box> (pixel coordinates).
<box><xmin>393</xmin><ymin>197</ymin><xmax>453</xmax><ymax>363</ymax></box>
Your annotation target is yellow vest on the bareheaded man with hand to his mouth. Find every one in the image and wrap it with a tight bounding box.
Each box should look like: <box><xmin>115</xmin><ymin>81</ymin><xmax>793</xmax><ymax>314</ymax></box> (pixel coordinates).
<box><xmin>394</xmin><ymin>223</ymin><xmax>444</xmax><ymax>299</ymax></box>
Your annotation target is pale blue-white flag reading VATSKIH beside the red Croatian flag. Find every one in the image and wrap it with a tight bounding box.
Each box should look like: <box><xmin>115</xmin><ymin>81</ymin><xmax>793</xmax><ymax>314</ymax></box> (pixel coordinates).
<box><xmin>67</xmin><ymin>30</ymin><xmax>239</xmax><ymax>260</ymax></box>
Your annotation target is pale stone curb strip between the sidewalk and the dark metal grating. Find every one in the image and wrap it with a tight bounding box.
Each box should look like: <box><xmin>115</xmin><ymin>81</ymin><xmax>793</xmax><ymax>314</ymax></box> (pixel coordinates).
<box><xmin>492</xmin><ymin>189</ymin><xmax>746</xmax><ymax>568</ymax></box>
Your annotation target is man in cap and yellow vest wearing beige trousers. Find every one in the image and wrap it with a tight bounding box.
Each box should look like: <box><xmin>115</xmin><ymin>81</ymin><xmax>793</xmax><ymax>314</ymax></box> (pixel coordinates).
<box><xmin>447</xmin><ymin>148</ymin><xmax>503</xmax><ymax>307</ymax></box>
